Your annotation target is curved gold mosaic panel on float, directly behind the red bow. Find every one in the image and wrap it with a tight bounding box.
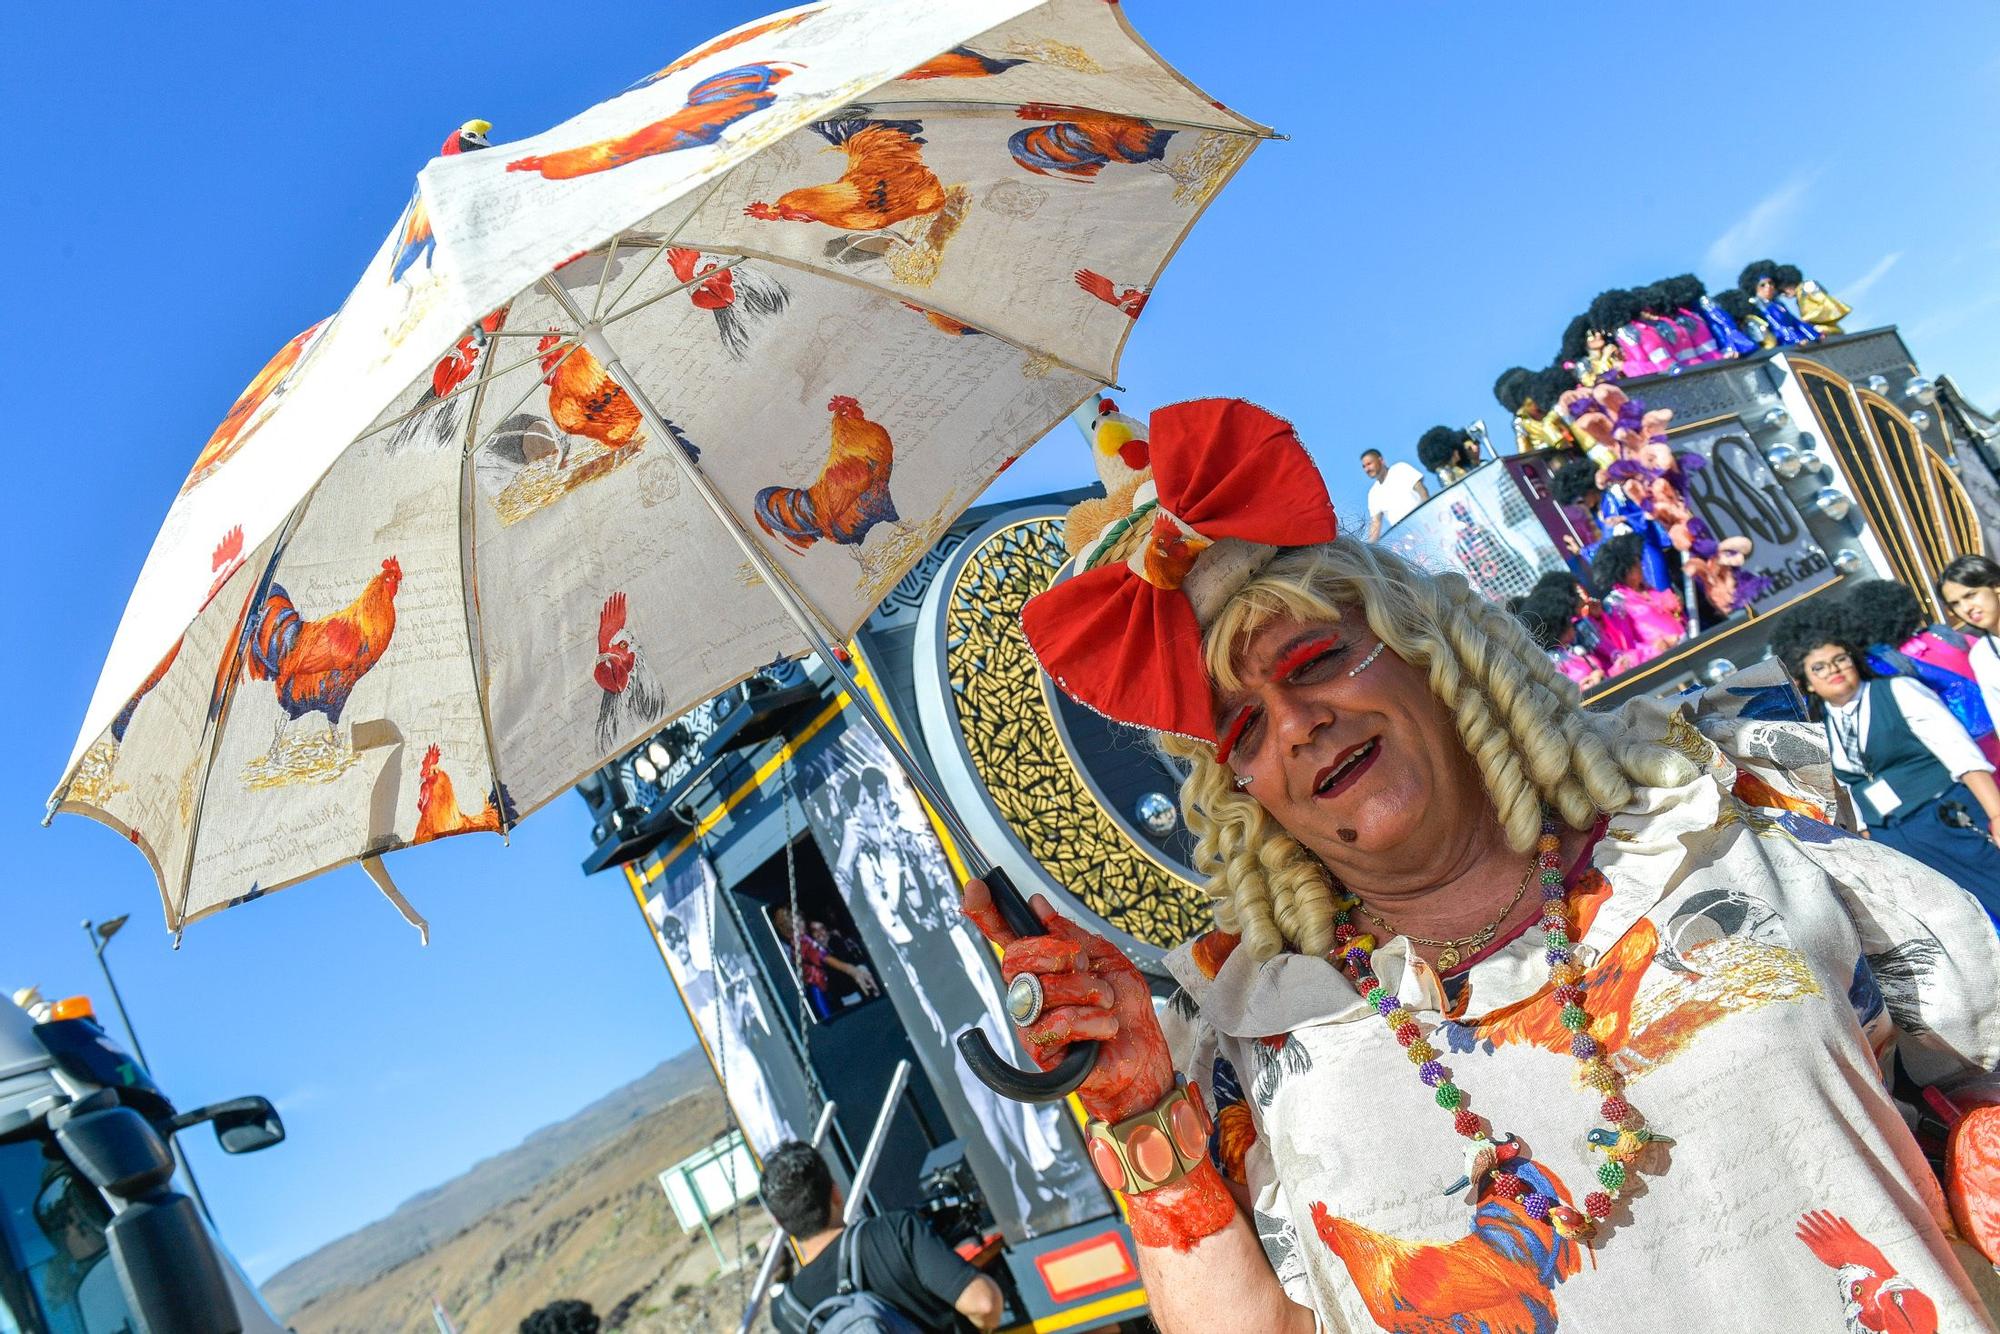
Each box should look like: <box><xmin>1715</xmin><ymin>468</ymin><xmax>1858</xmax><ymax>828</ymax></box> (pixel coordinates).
<box><xmin>944</xmin><ymin>516</ymin><xmax>1214</xmax><ymax>950</ymax></box>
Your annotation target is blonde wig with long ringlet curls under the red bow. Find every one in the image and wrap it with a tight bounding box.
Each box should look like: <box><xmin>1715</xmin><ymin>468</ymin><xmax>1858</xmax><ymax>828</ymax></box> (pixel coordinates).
<box><xmin>1160</xmin><ymin>536</ymin><xmax>1694</xmax><ymax>960</ymax></box>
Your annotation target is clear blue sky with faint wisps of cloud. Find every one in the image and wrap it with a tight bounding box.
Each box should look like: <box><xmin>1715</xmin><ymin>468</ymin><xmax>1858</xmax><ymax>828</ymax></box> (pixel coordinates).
<box><xmin>0</xmin><ymin>0</ymin><xmax>2000</xmax><ymax>1276</ymax></box>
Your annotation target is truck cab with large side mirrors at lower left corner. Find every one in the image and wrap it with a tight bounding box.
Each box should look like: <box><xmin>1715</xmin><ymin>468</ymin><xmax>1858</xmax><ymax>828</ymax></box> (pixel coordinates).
<box><xmin>0</xmin><ymin>998</ymin><xmax>284</xmax><ymax>1334</ymax></box>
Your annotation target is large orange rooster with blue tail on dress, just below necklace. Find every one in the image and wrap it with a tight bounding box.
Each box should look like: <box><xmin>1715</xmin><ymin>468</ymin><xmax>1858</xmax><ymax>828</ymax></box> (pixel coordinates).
<box><xmin>1312</xmin><ymin>1160</ymin><xmax>1582</xmax><ymax>1334</ymax></box>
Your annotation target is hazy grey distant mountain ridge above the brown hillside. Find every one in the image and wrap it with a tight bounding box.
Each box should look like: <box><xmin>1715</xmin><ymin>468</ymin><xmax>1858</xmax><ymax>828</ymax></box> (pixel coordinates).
<box><xmin>264</xmin><ymin>1048</ymin><xmax>722</xmax><ymax>1328</ymax></box>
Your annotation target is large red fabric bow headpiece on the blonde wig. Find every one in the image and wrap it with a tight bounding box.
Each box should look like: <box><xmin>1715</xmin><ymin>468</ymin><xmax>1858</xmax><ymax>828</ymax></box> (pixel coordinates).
<box><xmin>1020</xmin><ymin>398</ymin><xmax>1338</xmax><ymax>744</ymax></box>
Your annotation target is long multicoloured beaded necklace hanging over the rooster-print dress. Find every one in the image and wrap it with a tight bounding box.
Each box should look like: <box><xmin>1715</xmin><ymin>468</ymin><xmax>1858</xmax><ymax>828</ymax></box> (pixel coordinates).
<box><xmin>1332</xmin><ymin>812</ymin><xmax>1672</xmax><ymax>1242</ymax></box>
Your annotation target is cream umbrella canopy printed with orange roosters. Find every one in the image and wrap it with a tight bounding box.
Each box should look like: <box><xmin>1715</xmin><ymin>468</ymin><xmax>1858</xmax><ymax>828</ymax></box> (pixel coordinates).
<box><xmin>50</xmin><ymin>0</ymin><xmax>1268</xmax><ymax>928</ymax></box>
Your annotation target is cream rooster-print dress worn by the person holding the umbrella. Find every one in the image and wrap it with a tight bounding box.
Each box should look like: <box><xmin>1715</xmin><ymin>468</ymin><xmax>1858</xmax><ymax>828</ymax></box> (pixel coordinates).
<box><xmin>1164</xmin><ymin>686</ymin><xmax>2000</xmax><ymax>1334</ymax></box>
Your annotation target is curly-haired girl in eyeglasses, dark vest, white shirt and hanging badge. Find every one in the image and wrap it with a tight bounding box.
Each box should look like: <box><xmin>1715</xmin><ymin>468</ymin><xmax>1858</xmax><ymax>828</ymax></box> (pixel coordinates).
<box><xmin>1778</xmin><ymin>612</ymin><xmax>2000</xmax><ymax>922</ymax></box>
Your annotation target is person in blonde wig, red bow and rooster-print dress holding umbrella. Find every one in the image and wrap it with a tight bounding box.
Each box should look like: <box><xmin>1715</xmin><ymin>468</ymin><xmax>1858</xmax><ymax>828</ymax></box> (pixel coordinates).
<box><xmin>966</xmin><ymin>400</ymin><xmax>2000</xmax><ymax>1334</ymax></box>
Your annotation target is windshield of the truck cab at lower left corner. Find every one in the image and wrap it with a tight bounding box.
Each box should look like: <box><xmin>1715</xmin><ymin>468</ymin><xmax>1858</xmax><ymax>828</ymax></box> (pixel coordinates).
<box><xmin>0</xmin><ymin>1140</ymin><xmax>136</xmax><ymax>1334</ymax></box>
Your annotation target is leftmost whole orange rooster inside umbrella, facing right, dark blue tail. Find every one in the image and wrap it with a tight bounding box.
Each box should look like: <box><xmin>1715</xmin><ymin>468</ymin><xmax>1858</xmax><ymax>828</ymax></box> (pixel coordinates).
<box><xmin>242</xmin><ymin>554</ymin><xmax>402</xmax><ymax>750</ymax></box>
